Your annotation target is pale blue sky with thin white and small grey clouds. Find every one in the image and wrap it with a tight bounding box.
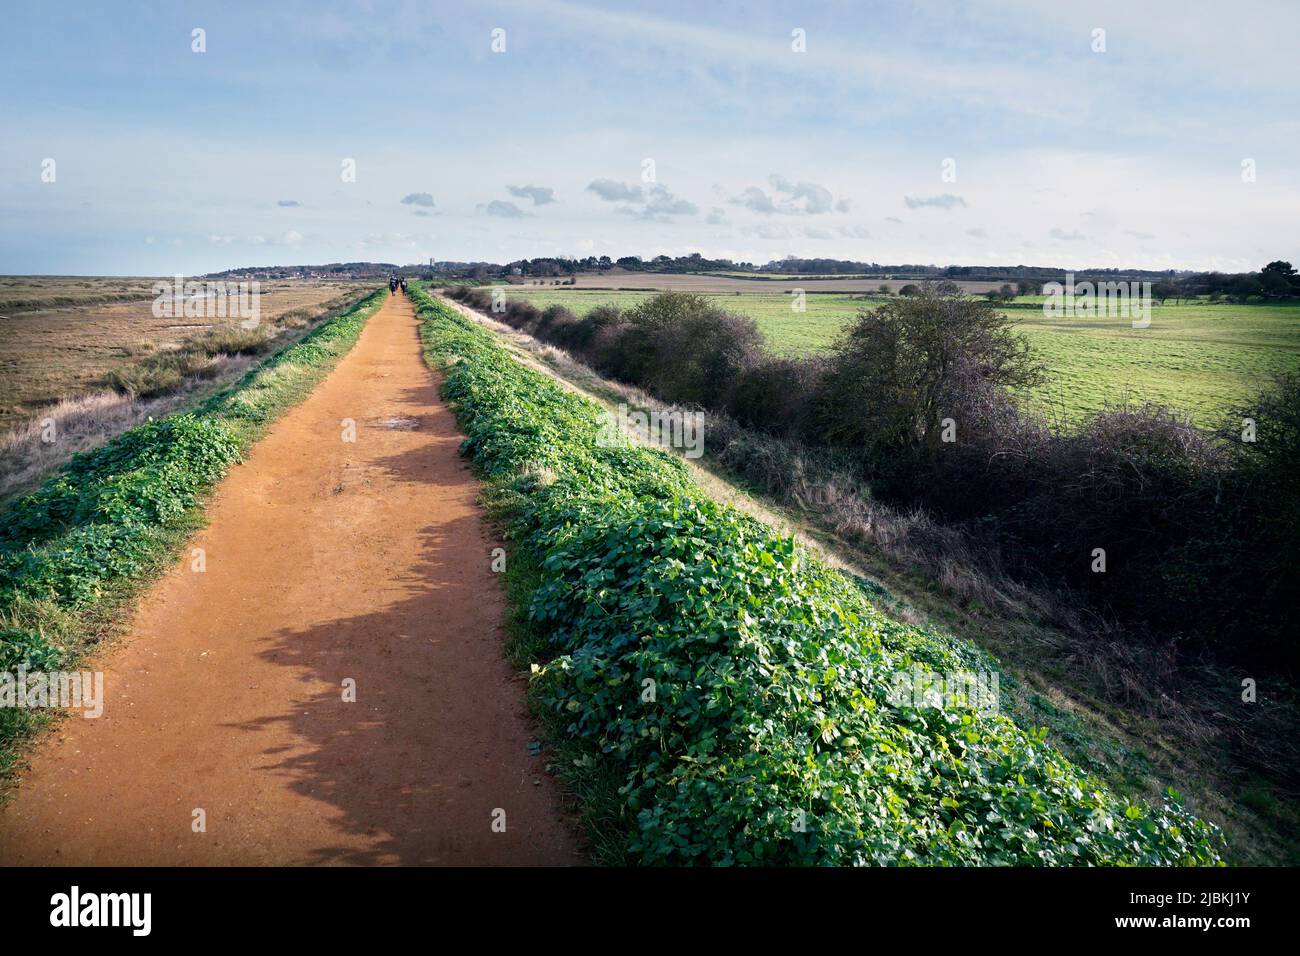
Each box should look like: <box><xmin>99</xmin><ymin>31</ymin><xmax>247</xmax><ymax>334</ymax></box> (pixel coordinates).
<box><xmin>0</xmin><ymin>0</ymin><xmax>1300</xmax><ymax>276</ymax></box>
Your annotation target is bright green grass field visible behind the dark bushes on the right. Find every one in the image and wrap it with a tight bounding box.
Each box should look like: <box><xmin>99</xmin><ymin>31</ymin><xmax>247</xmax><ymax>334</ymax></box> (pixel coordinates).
<box><xmin>496</xmin><ymin>287</ymin><xmax>1300</xmax><ymax>427</ymax></box>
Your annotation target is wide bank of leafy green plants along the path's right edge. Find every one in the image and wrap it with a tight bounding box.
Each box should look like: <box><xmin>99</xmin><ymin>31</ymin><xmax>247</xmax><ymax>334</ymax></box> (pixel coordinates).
<box><xmin>413</xmin><ymin>283</ymin><xmax>1222</xmax><ymax>865</ymax></box>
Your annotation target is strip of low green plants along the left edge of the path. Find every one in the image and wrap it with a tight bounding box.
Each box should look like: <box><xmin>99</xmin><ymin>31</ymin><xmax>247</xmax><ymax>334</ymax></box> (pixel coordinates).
<box><xmin>0</xmin><ymin>291</ymin><xmax>387</xmax><ymax>771</ymax></box>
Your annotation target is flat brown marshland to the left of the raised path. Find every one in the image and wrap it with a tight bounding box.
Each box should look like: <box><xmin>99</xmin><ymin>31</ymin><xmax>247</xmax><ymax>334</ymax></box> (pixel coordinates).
<box><xmin>0</xmin><ymin>276</ymin><xmax>371</xmax><ymax>432</ymax></box>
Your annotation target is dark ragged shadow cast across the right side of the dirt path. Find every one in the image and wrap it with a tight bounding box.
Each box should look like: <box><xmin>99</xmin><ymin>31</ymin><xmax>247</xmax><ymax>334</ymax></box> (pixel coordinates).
<box><xmin>218</xmin><ymin>380</ymin><xmax>584</xmax><ymax>865</ymax></box>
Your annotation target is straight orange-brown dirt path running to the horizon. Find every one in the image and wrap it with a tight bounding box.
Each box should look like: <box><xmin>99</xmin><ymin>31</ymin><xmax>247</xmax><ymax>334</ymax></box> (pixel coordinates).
<box><xmin>0</xmin><ymin>291</ymin><xmax>582</xmax><ymax>865</ymax></box>
